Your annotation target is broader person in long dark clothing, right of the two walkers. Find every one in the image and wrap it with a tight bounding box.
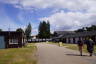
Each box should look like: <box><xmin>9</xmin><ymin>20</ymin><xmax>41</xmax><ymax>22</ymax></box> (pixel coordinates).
<box><xmin>85</xmin><ymin>38</ymin><xmax>95</xmax><ymax>56</ymax></box>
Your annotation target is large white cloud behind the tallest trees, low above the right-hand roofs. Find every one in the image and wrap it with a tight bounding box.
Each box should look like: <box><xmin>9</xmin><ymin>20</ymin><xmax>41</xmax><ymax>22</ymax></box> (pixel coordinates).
<box><xmin>39</xmin><ymin>11</ymin><xmax>96</xmax><ymax>30</ymax></box>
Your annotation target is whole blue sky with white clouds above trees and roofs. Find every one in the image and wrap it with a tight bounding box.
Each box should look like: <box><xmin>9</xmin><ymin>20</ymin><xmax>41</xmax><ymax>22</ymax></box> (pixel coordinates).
<box><xmin>0</xmin><ymin>0</ymin><xmax>96</xmax><ymax>35</ymax></box>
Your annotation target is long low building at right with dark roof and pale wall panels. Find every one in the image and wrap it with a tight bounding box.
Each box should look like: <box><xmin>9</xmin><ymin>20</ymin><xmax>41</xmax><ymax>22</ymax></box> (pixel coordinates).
<box><xmin>52</xmin><ymin>31</ymin><xmax>96</xmax><ymax>43</ymax></box>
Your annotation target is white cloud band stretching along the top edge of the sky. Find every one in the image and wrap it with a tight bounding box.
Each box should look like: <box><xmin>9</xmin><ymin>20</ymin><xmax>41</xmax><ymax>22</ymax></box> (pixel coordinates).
<box><xmin>0</xmin><ymin>0</ymin><xmax>96</xmax><ymax>12</ymax></box>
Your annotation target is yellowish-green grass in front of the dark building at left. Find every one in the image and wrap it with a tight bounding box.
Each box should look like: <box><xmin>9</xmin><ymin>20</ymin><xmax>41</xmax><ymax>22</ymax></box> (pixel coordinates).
<box><xmin>0</xmin><ymin>43</ymin><xmax>37</xmax><ymax>64</ymax></box>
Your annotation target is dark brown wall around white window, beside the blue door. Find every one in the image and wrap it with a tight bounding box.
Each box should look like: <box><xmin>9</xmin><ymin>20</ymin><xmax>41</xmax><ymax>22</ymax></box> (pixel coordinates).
<box><xmin>0</xmin><ymin>32</ymin><xmax>24</xmax><ymax>48</ymax></box>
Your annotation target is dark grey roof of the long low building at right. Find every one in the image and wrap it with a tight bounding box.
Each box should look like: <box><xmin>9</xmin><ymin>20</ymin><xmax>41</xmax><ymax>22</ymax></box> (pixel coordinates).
<box><xmin>54</xmin><ymin>31</ymin><xmax>96</xmax><ymax>38</ymax></box>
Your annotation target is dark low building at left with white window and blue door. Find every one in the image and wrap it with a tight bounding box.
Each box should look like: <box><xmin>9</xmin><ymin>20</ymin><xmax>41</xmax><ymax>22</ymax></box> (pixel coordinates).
<box><xmin>0</xmin><ymin>31</ymin><xmax>26</xmax><ymax>48</ymax></box>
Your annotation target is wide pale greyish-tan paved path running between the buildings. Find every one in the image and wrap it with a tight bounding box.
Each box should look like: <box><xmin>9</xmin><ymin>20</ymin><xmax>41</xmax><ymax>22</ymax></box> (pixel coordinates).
<box><xmin>36</xmin><ymin>43</ymin><xmax>96</xmax><ymax>64</ymax></box>
